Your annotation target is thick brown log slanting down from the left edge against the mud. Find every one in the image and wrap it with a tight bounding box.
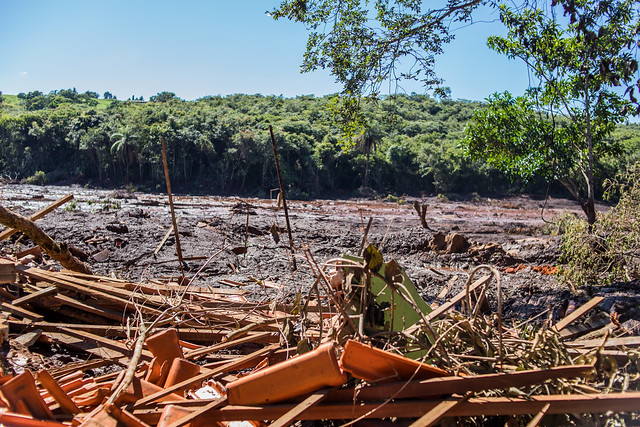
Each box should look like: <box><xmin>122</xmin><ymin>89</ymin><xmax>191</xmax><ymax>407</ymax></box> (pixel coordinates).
<box><xmin>0</xmin><ymin>206</ymin><xmax>93</xmax><ymax>274</ymax></box>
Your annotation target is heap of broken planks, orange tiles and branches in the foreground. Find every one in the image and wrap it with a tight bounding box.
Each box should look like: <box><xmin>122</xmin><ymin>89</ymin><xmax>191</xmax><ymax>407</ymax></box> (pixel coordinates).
<box><xmin>0</xmin><ymin>193</ymin><xmax>640</xmax><ymax>427</ymax></box>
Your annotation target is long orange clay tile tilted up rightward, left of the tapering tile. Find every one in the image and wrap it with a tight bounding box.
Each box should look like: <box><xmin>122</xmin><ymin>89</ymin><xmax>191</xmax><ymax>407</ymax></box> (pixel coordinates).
<box><xmin>227</xmin><ymin>342</ymin><xmax>347</xmax><ymax>405</ymax></box>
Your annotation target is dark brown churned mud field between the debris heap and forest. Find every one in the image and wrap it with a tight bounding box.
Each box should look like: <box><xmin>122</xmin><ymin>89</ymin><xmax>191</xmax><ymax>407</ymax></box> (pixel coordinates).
<box><xmin>0</xmin><ymin>181</ymin><xmax>640</xmax><ymax>328</ymax></box>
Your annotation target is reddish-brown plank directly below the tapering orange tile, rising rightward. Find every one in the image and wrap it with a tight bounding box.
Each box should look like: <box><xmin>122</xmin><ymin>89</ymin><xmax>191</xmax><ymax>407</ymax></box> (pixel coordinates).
<box><xmin>327</xmin><ymin>365</ymin><xmax>593</xmax><ymax>402</ymax></box>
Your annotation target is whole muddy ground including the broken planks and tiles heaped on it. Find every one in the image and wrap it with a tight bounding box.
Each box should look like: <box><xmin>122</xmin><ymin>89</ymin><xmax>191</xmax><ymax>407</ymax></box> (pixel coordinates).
<box><xmin>0</xmin><ymin>186</ymin><xmax>640</xmax><ymax>426</ymax></box>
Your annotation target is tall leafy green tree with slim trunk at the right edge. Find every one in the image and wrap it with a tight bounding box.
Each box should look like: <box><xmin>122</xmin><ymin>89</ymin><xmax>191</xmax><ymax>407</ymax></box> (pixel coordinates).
<box><xmin>464</xmin><ymin>0</ymin><xmax>640</xmax><ymax>224</ymax></box>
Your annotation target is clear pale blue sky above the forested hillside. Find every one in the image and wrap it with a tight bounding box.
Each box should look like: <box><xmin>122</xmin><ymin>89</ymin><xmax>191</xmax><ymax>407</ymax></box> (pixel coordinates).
<box><xmin>0</xmin><ymin>0</ymin><xmax>527</xmax><ymax>100</ymax></box>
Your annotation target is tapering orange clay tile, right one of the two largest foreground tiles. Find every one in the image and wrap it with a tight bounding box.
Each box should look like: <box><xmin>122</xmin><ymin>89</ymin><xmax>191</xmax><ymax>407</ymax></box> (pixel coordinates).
<box><xmin>340</xmin><ymin>340</ymin><xmax>449</xmax><ymax>382</ymax></box>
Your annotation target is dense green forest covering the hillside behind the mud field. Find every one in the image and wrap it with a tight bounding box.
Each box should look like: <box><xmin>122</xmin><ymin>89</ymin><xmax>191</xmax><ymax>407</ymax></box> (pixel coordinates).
<box><xmin>0</xmin><ymin>89</ymin><xmax>640</xmax><ymax>198</ymax></box>
